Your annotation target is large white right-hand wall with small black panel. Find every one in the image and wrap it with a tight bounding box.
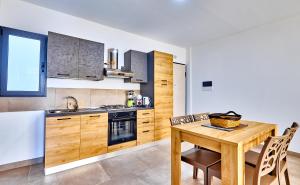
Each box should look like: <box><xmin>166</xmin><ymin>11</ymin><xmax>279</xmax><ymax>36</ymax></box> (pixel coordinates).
<box><xmin>190</xmin><ymin>16</ymin><xmax>300</xmax><ymax>152</ymax></box>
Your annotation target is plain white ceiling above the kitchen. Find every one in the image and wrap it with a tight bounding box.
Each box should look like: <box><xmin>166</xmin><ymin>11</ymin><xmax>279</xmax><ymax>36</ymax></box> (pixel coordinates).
<box><xmin>24</xmin><ymin>0</ymin><xmax>300</xmax><ymax>46</ymax></box>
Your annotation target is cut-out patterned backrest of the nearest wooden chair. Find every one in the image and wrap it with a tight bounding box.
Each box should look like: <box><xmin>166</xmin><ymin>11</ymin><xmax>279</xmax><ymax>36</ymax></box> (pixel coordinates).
<box><xmin>253</xmin><ymin>129</ymin><xmax>290</xmax><ymax>185</ymax></box>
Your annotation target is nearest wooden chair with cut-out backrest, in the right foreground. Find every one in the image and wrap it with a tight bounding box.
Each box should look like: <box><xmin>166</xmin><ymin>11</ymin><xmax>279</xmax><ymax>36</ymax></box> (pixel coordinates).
<box><xmin>208</xmin><ymin>129</ymin><xmax>290</xmax><ymax>185</ymax></box>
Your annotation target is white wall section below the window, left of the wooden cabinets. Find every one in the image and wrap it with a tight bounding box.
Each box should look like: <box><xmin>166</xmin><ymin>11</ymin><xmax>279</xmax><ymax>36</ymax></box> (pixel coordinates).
<box><xmin>0</xmin><ymin>111</ymin><xmax>44</xmax><ymax>165</ymax></box>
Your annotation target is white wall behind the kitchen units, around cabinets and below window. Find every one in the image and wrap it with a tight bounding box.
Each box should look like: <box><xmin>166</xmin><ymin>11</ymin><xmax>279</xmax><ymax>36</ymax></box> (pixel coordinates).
<box><xmin>0</xmin><ymin>0</ymin><xmax>186</xmax><ymax>165</ymax></box>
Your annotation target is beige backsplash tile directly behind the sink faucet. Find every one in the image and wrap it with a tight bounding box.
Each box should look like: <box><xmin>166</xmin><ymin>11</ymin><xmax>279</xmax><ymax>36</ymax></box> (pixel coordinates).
<box><xmin>55</xmin><ymin>89</ymin><xmax>91</xmax><ymax>109</ymax></box>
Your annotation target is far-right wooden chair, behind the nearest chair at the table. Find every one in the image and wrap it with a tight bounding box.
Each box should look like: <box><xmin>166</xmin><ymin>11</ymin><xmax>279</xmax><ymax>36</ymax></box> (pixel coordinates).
<box><xmin>245</xmin><ymin>122</ymin><xmax>299</xmax><ymax>185</ymax></box>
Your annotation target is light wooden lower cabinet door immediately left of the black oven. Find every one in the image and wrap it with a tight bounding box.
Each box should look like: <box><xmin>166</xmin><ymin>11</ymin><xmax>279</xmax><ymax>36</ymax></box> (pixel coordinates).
<box><xmin>80</xmin><ymin>113</ymin><xmax>108</xmax><ymax>159</ymax></box>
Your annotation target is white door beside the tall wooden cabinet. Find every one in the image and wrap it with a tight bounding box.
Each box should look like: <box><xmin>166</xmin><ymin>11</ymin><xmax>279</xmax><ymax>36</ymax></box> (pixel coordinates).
<box><xmin>173</xmin><ymin>63</ymin><xmax>186</xmax><ymax>116</ymax></box>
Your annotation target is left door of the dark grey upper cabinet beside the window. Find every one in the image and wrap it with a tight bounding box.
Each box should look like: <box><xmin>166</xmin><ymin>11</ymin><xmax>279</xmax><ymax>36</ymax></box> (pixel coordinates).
<box><xmin>48</xmin><ymin>32</ymin><xmax>79</xmax><ymax>78</ymax></box>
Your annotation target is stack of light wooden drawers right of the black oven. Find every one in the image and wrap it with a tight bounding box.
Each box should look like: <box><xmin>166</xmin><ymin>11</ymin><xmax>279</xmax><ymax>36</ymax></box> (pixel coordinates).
<box><xmin>137</xmin><ymin>109</ymin><xmax>154</xmax><ymax>145</ymax></box>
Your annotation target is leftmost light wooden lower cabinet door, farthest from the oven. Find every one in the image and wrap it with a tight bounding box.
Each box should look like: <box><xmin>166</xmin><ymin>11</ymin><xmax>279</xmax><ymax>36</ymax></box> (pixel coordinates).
<box><xmin>45</xmin><ymin>116</ymin><xmax>80</xmax><ymax>168</ymax></box>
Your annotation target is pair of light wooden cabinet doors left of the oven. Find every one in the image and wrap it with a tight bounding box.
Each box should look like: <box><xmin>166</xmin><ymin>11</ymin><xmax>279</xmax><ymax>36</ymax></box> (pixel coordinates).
<box><xmin>45</xmin><ymin>113</ymin><xmax>108</xmax><ymax>168</ymax></box>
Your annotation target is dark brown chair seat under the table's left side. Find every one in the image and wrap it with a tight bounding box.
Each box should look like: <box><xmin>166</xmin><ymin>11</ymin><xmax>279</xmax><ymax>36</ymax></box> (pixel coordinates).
<box><xmin>181</xmin><ymin>148</ymin><xmax>221</xmax><ymax>169</ymax></box>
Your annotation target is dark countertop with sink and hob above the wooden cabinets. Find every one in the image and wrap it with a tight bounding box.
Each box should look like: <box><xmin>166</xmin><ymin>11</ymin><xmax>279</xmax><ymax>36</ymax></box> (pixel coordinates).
<box><xmin>45</xmin><ymin>107</ymin><xmax>153</xmax><ymax>117</ymax></box>
